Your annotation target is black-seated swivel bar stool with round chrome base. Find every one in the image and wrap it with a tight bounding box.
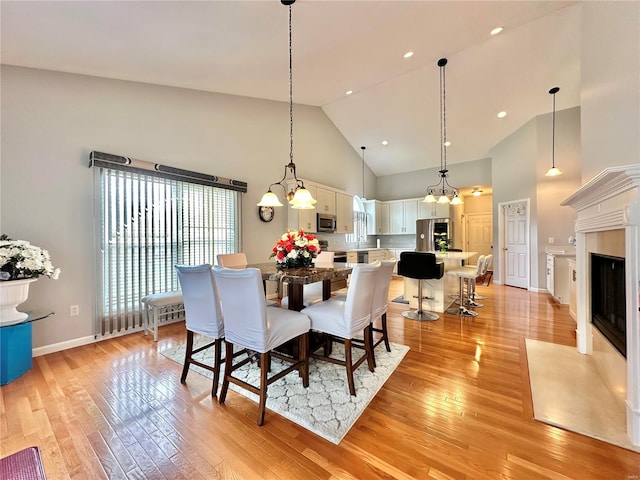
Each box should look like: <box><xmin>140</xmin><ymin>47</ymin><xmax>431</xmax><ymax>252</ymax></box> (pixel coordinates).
<box><xmin>398</xmin><ymin>252</ymin><xmax>444</xmax><ymax>321</ymax></box>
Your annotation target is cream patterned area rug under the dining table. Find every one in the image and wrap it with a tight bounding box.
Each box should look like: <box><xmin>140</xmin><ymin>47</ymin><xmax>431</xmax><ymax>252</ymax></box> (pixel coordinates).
<box><xmin>160</xmin><ymin>336</ymin><xmax>409</xmax><ymax>445</ymax></box>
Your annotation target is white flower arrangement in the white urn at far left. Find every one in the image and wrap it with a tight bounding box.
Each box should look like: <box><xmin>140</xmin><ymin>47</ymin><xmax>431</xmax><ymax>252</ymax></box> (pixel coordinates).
<box><xmin>0</xmin><ymin>234</ymin><xmax>60</xmax><ymax>281</ymax></box>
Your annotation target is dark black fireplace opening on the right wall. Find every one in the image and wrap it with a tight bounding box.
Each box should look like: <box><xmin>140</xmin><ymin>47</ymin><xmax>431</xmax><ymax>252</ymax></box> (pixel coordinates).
<box><xmin>591</xmin><ymin>253</ymin><xmax>627</xmax><ymax>358</ymax></box>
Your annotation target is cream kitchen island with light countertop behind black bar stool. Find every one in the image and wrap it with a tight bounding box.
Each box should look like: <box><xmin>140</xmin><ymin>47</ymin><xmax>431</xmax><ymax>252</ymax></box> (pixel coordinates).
<box><xmin>398</xmin><ymin>252</ymin><xmax>477</xmax><ymax>313</ymax></box>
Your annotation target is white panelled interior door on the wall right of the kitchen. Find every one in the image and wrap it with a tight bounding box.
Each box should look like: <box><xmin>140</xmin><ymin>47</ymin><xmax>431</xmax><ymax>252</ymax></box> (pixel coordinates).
<box><xmin>502</xmin><ymin>200</ymin><xmax>529</xmax><ymax>289</ymax></box>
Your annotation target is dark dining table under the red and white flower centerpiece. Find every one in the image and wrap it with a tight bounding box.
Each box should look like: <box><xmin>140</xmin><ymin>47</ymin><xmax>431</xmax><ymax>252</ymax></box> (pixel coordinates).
<box><xmin>247</xmin><ymin>262</ymin><xmax>353</xmax><ymax>312</ymax></box>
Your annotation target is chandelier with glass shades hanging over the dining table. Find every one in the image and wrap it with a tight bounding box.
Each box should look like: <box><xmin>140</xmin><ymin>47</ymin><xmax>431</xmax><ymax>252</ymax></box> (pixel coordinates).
<box><xmin>258</xmin><ymin>0</ymin><xmax>317</xmax><ymax>210</ymax></box>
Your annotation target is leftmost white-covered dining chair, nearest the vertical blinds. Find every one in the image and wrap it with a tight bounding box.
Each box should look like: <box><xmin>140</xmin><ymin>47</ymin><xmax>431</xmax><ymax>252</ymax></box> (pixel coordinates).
<box><xmin>176</xmin><ymin>264</ymin><xmax>224</xmax><ymax>397</ymax></box>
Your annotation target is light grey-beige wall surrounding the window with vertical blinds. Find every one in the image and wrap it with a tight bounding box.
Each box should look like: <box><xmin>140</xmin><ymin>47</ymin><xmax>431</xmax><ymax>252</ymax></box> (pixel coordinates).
<box><xmin>0</xmin><ymin>65</ymin><xmax>364</xmax><ymax>347</ymax></box>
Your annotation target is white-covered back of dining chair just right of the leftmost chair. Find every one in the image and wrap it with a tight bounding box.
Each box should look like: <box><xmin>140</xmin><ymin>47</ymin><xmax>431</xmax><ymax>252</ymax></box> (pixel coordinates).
<box><xmin>213</xmin><ymin>266</ymin><xmax>268</xmax><ymax>352</ymax></box>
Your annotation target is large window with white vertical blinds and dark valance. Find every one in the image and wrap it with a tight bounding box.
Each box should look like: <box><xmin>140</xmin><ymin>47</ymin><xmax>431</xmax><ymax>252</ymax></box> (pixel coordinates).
<box><xmin>90</xmin><ymin>152</ymin><xmax>246</xmax><ymax>335</ymax></box>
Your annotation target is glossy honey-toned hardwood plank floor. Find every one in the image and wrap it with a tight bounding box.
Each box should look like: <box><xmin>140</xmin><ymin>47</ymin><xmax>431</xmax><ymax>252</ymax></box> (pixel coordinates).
<box><xmin>0</xmin><ymin>279</ymin><xmax>640</xmax><ymax>480</ymax></box>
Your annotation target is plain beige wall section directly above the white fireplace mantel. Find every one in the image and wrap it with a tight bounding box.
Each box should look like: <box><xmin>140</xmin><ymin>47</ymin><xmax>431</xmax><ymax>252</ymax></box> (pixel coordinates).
<box><xmin>580</xmin><ymin>1</ymin><xmax>640</xmax><ymax>184</ymax></box>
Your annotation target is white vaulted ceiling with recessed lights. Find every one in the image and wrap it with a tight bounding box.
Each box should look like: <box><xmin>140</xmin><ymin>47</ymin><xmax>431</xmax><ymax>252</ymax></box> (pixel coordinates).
<box><xmin>0</xmin><ymin>0</ymin><xmax>580</xmax><ymax>176</ymax></box>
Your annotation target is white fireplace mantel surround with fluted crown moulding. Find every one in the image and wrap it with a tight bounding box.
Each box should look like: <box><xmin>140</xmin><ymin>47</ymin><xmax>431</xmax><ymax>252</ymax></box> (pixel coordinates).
<box><xmin>561</xmin><ymin>164</ymin><xmax>640</xmax><ymax>446</ymax></box>
